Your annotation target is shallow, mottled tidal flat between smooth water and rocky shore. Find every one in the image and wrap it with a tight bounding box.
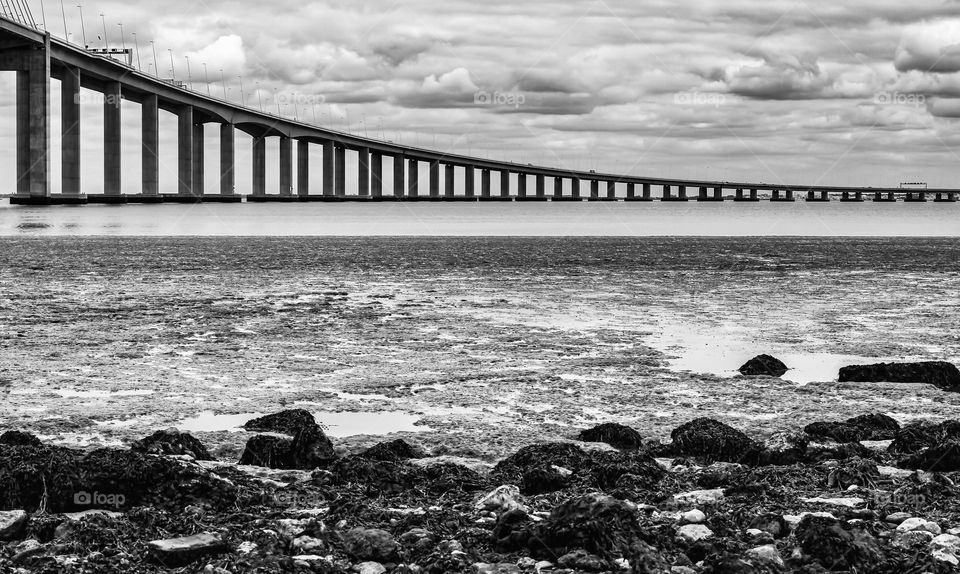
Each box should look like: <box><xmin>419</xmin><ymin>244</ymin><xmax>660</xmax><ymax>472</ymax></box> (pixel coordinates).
<box><xmin>0</xmin><ymin>237</ymin><xmax>960</xmax><ymax>456</ymax></box>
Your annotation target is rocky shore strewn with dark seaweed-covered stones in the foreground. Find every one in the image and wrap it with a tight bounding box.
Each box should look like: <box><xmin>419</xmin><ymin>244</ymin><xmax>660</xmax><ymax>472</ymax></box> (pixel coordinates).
<box><xmin>0</xmin><ymin>400</ymin><xmax>960</xmax><ymax>574</ymax></box>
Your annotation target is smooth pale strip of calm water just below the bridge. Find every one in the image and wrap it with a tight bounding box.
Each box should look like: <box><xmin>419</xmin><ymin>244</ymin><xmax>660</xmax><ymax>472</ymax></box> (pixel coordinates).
<box><xmin>0</xmin><ymin>201</ymin><xmax>960</xmax><ymax>237</ymax></box>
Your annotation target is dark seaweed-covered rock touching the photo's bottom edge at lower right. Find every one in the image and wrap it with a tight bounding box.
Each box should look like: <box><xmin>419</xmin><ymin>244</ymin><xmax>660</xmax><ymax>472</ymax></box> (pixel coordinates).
<box><xmin>794</xmin><ymin>515</ymin><xmax>881</xmax><ymax>572</ymax></box>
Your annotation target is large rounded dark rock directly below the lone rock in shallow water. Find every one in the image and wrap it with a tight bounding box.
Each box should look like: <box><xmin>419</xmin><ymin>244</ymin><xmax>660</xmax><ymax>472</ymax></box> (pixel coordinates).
<box><xmin>670</xmin><ymin>418</ymin><xmax>761</xmax><ymax>463</ymax></box>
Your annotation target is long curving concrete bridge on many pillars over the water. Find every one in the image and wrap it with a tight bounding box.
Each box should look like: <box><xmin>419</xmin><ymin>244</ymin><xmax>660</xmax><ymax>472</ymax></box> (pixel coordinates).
<box><xmin>0</xmin><ymin>14</ymin><xmax>960</xmax><ymax>205</ymax></box>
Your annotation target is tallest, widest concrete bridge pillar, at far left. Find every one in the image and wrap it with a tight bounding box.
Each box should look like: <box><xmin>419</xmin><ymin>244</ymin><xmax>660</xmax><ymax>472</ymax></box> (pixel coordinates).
<box><xmin>17</xmin><ymin>42</ymin><xmax>50</xmax><ymax>201</ymax></box>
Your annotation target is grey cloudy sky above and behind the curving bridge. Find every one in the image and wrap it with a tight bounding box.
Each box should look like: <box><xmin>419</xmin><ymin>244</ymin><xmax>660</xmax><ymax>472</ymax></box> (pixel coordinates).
<box><xmin>3</xmin><ymin>0</ymin><xmax>960</xmax><ymax>191</ymax></box>
